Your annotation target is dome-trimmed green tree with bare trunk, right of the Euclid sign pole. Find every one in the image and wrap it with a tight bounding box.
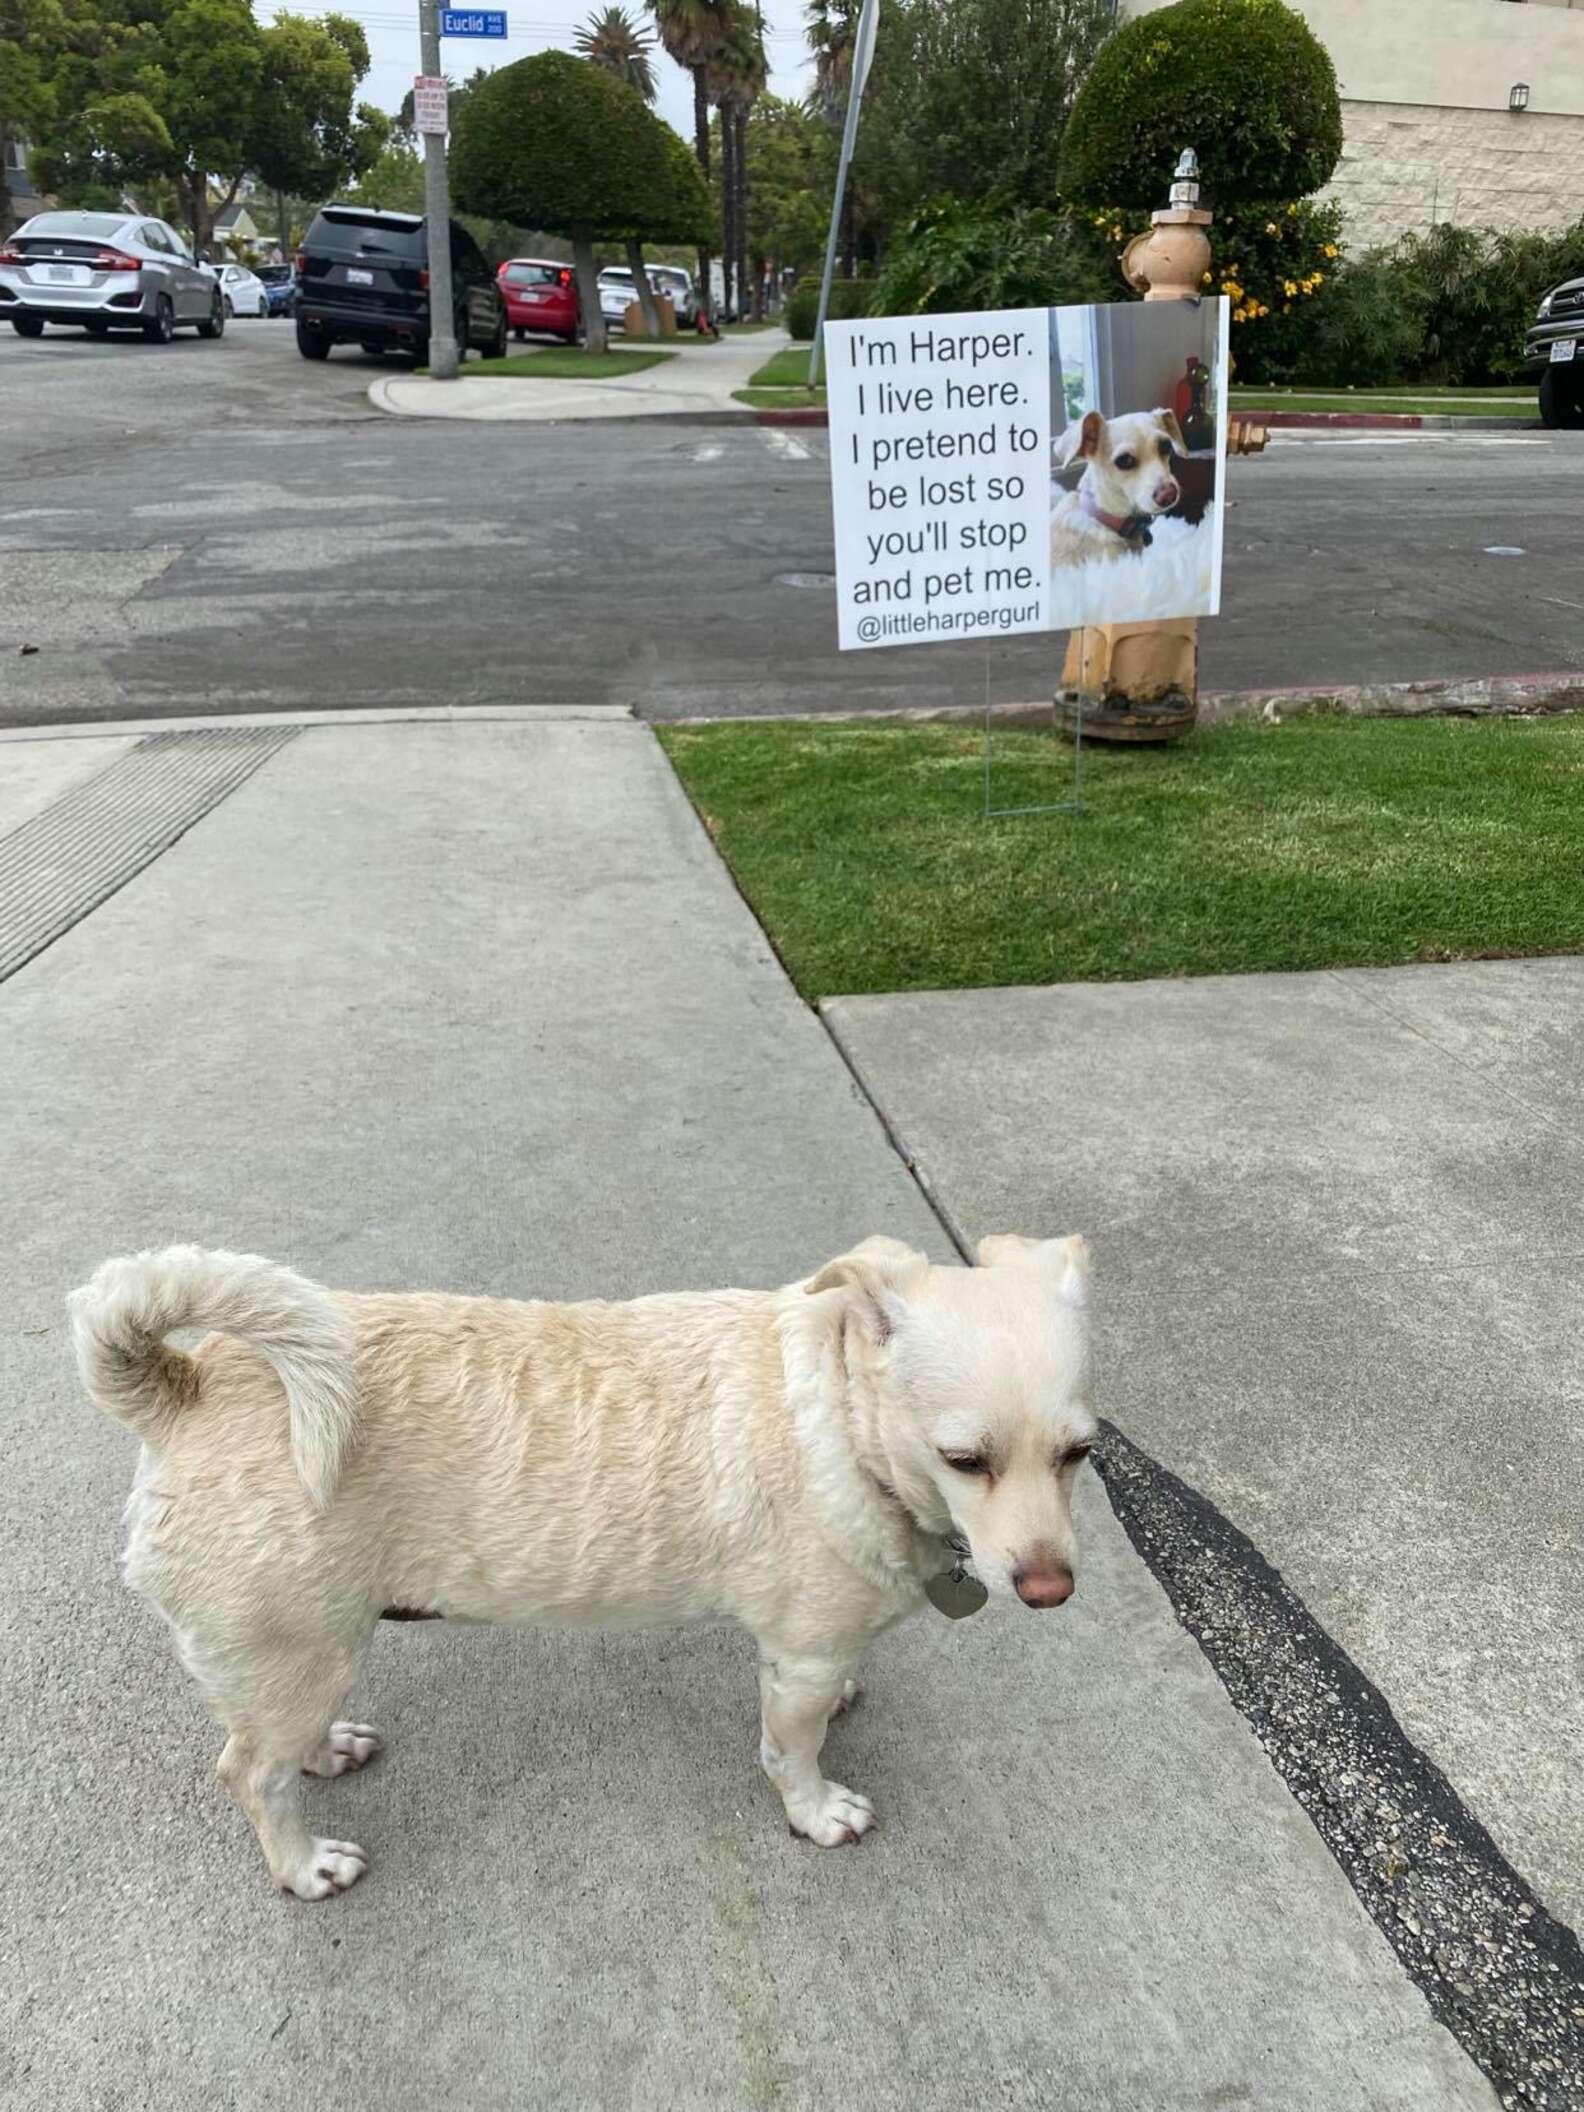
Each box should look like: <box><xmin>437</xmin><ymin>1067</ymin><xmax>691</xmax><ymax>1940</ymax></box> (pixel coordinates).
<box><xmin>450</xmin><ymin>51</ymin><xmax>697</xmax><ymax>353</ymax></box>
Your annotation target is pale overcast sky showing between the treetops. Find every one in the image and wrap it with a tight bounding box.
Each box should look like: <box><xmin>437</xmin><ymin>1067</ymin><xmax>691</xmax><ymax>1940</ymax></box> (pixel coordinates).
<box><xmin>287</xmin><ymin>0</ymin><xmax>811</xmax><ymax>139</ymax></box>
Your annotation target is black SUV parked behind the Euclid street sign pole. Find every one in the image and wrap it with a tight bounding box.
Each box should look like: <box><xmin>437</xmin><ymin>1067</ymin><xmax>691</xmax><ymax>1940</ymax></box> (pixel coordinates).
<box><xmin>296</xmin><ymin>205</ymin><xmax>507</xmax><ymax>365</ymax></box>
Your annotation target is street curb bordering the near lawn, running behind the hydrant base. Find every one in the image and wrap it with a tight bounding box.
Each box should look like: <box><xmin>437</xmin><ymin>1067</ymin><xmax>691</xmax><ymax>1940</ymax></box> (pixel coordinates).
<box><xmin>650</xmin><ymin>670</ymin><xmax>1584</xmax><ymax>727</ymax></box>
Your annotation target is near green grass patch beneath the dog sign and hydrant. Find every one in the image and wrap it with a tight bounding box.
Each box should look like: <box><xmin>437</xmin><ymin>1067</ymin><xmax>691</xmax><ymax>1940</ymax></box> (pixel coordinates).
<box><xmin>659</xmin><ymin>716</ymin><xmax>1584</xmax><ymax>999</ymax></box>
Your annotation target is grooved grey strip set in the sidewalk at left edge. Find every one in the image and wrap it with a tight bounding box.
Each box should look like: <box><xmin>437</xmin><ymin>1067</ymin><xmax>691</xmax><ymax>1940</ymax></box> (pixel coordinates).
<box><xmin>0</xmin><ymin>727</ymin><xmax>300</xmax><ymax>980</ymax></box>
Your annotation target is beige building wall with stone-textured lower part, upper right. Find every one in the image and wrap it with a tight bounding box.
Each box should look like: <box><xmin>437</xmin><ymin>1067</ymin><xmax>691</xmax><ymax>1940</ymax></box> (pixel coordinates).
<box><xmin>1124</xmin><ymin>0</ymin><xmax>1584</xmax><ymax>249</ymax></box>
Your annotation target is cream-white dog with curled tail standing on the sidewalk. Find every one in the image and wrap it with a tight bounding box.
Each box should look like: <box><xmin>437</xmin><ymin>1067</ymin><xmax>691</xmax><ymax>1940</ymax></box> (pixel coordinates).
<box><xmin>70</xmin><ymin>1238</ymin><xmax>1096</xmax><ymax>1899</ymax></box>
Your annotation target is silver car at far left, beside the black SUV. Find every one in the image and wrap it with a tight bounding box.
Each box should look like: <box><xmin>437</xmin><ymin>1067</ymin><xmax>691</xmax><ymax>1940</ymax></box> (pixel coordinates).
<box><xmin>0</xmin><ymin>213</ymin><xmax>226</xmax><ymax>344</ymax></box>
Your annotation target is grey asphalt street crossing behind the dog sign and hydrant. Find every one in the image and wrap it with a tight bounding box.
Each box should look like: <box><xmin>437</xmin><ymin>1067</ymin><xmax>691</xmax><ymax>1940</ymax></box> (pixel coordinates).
<box><xmin>0</xmin><ymin>321</ymin><xmax>1584</xmax><ymax>724</ymax></box>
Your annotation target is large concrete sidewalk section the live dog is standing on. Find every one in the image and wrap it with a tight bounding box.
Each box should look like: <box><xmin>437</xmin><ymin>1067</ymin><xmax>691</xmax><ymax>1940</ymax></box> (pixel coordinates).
<box><xmin>0</xmin><ymin>720</ymin><xmax>1495</xmax><ymax>2112</ymax></box>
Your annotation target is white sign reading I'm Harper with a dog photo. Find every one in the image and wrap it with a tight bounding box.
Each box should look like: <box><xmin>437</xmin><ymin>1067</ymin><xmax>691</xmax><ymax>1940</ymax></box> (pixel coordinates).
<box><xmin>826</xmin><ymin>300</ymin><xmax>1227</xmax><ymax>648</ymax></box>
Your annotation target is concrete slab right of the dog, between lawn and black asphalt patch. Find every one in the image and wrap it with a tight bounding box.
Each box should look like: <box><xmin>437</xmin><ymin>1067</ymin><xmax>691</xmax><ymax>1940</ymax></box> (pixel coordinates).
<box><xmin>824</xmin><ymin>957</ymin><xmax>1584</xmax><ymax>2106</ymax></box>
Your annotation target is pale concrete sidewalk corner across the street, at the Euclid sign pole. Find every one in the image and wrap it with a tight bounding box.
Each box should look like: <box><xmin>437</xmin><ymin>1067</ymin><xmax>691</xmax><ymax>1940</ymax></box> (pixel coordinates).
<box><xmin>367</xmin><ymin>329</ymin><xmax>792</xmax><ymax>425</ymax></box>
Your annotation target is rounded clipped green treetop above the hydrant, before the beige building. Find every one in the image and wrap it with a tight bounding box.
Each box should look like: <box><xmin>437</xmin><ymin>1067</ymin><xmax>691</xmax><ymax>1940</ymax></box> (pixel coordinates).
<box><xmin>1060</xmin><ymin>0</ymin><xmax>1341</xmax><ymax>207</ymax></box>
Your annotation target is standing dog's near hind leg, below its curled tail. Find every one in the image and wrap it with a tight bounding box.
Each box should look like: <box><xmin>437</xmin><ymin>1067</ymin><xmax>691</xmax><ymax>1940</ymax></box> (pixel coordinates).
<box><xmin>205</xmin><ymin>1637</ymin><xmax>378</xmax><ymax>1899</ymax></box>
